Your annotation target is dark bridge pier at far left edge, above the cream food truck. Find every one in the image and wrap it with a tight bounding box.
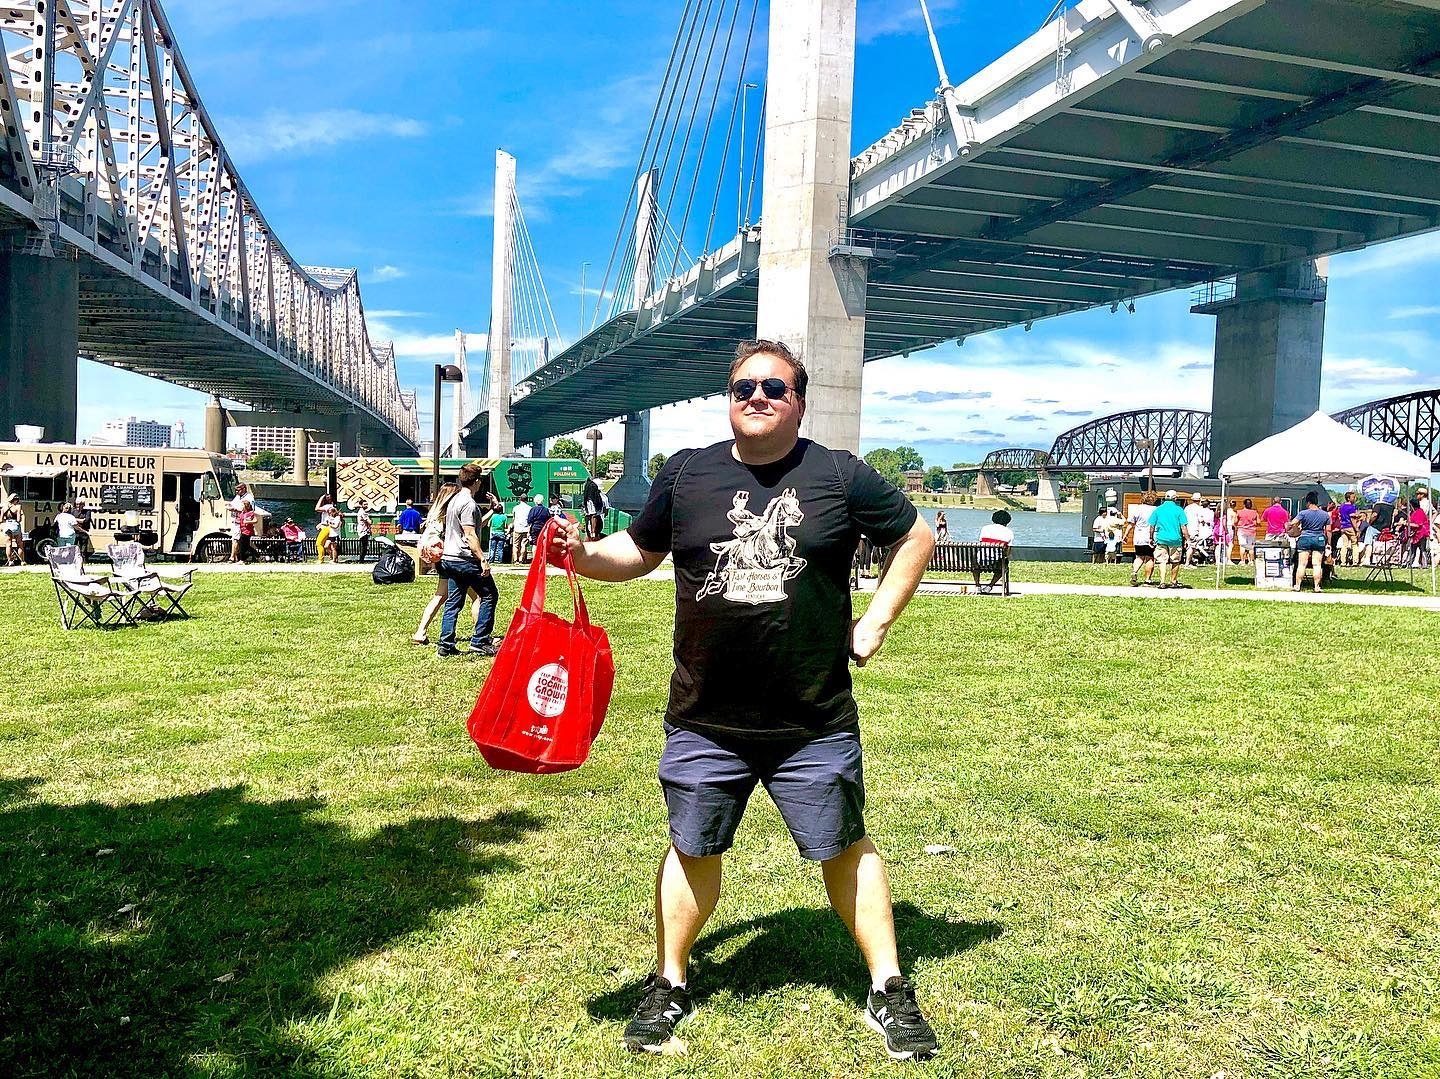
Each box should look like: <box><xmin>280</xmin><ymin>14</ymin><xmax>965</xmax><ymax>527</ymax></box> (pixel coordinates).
<box><xmin>0</xmin><ymin>252</ymin><xmax>81</xmax><ymax>442</ymax></box>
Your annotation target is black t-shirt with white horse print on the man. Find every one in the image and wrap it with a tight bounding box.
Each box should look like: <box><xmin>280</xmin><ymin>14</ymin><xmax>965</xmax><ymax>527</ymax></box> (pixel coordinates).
<box><xmin>629</xmin><ymin>438</ymin><xmax>916</xmax><ymax>740</ymax></box>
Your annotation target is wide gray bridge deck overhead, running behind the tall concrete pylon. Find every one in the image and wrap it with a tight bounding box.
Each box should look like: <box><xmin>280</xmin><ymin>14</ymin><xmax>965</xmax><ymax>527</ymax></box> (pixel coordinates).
<box><xmin>469</xmin><ymin>0</ymin><xmax>1440</xmax><ymax>486</ymax></box>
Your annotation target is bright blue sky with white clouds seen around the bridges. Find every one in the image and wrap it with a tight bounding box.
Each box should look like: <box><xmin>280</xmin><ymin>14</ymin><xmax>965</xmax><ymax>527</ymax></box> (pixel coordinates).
<box><xmin>79</xmin><ymin>0</ymin><xmax>1440</xmax><ymax>465</ymax></box>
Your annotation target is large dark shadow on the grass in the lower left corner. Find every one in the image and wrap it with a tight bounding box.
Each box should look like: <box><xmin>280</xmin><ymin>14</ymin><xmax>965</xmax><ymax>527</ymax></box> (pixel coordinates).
<box><xmin>0</xmin><ymin>779</ymin><xmax>543</xmax><ymax>1076</ymax></box>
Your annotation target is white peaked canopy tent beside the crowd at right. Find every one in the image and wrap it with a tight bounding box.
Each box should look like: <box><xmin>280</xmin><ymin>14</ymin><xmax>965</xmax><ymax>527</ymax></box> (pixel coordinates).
<box><xmin>1215</xmin><ymin>412</ymin><xmax>1436</xmax><ymax>594</ymax></box>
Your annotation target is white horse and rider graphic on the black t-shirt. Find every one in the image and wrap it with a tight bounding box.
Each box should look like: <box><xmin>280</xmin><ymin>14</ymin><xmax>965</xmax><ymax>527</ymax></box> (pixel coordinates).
<box><xmin>696</xmin><ymin>487</ymin><xmax>806</xmax><ymax>604</ymax></box>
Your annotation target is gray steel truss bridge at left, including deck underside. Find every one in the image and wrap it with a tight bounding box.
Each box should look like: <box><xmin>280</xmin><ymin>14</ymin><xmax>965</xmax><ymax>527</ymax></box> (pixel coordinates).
<box><xmin>0</xmin><ymin>0</ymin><xmax>418</xmax><ymax>452</ymax></box>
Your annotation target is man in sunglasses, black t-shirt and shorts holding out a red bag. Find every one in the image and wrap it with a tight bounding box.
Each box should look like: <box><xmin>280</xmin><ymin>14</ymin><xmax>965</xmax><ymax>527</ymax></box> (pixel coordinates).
<box><xmin>549</xmin><ymin>341</ymin><xmax>936</xmax><ymax>1059</ymax></box>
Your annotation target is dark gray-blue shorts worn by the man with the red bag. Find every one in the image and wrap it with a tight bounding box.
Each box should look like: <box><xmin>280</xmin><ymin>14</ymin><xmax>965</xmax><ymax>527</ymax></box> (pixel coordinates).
<box><xmin>660</xmin><ymin>723</ymin><xmax>865</xmax><ymax>861</ymax></box>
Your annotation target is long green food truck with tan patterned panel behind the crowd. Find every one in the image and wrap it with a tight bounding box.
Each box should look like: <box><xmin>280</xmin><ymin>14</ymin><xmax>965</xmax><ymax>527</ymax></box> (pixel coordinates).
<box><xmin>328</xmin><ymin>457</ymin><xmax>629</xmax><ymax>534</ymax></box>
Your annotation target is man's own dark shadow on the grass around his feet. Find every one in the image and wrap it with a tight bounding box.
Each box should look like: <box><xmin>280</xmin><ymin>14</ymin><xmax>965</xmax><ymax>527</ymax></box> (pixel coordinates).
<box><xmin>589</xmin><ymin>902</ymin><xmax>1004</xmax><ymax>1020</ymax></box>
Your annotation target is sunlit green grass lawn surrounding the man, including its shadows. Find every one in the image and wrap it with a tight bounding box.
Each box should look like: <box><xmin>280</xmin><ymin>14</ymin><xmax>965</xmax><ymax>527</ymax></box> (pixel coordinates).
<box><xmin>0</xmin><ymin>568</ymin><xmax>1440</xmax><ymax>1079</ymax></box>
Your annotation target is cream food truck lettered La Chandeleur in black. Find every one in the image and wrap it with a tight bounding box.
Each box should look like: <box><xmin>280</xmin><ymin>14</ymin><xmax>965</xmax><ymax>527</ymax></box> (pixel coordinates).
<box><xmin>0</xmin><ymin>442</ymin><xmax>235</xmax><ymax>559</ymax></box>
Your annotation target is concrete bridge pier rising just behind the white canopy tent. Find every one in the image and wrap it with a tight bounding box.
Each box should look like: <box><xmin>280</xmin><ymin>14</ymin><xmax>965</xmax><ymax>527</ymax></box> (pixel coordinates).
<box><xmin>1191</xmin><ymin>258</ymin><xmax>1328</xmax><ymax>475</ymax></box>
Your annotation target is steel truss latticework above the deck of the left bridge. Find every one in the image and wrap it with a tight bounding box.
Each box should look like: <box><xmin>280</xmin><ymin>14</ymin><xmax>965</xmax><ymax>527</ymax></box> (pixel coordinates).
<box><xmin>0</xmin><ymin>0</ymin><xmax>418</xmax><ymax>444</ymax></box>
